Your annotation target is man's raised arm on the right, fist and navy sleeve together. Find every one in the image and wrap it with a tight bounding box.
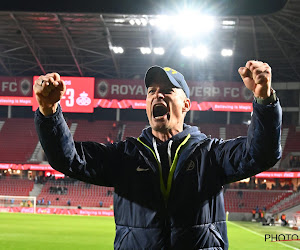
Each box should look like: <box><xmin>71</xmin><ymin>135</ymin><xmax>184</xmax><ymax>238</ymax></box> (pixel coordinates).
<box><xmin>211</xmin><ymin>61</ymin><xmax>282</xmax><ymax>184</ymax></box>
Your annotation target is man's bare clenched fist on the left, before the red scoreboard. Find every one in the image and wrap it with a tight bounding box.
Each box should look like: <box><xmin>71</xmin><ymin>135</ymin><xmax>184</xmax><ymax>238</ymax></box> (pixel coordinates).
<box><xmin>33</xmin><ymin>73</ymin><xmax>66</xmax><ymax>116</ymax></box>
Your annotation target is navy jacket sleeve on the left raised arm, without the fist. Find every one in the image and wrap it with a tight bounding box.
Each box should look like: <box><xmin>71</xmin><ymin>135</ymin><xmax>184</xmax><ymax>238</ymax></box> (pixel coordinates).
<box><xmin>34</xmin><ymin>106</ymin><xmax>123</xmax><ymax>186</ymax></box>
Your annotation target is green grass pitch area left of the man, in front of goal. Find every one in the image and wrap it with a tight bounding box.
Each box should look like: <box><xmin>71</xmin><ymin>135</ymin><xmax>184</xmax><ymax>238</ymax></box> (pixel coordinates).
<box><xmin>0</xmin><ymin>213</ymin><xmax>115</xmax><ymax>250</ymax></box>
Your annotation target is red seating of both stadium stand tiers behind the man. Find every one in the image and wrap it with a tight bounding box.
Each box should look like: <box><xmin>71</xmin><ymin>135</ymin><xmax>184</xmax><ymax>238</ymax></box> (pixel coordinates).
<box><xmin>0</xmin><ymin>118</ymin><xmax>300</xmax><ymax>212</ymax></box>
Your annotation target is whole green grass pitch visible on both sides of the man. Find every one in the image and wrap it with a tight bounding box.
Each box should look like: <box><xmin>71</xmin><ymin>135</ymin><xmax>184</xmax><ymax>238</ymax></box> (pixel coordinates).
<box><xmin>0</xmin><ymin>213</ymin><xmax>300</xmax><ymax>250</ymax></box>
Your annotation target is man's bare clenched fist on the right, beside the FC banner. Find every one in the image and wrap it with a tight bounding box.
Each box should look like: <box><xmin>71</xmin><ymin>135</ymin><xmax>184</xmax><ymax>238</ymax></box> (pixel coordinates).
<box><xmin>238</xmin><ymin>61</ymin><xmax>272</xmax><ymax>99</ymax></box>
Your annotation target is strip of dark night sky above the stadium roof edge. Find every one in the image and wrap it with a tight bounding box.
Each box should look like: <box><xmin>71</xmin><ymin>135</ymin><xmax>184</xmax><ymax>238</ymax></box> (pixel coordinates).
<box><xmin>0</xmin><ymin>0</ymin><xmax>287</xmax><ymax>16</ymax></box>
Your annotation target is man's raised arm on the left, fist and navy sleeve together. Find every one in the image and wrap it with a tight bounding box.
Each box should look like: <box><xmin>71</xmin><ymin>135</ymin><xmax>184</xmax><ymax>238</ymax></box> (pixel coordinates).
<box><xmin>34</xmin><ymin>73</ymin><xmax>123</xmax><ymax>186</ymax></box>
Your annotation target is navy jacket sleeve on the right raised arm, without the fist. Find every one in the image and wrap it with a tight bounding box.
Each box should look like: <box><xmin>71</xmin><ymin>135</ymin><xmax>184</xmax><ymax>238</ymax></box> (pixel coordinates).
<box><xmin>210</xmin><ymin>99</ymin><xmax>282</xmax><ymax>184</ymax></box>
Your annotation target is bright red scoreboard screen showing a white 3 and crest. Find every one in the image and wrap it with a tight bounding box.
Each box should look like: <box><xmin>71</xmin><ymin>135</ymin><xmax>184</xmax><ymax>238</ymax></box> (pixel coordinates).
<box><xmin>32</xmin><ymin>76</ymin><xmax>94</xmax><ymax>113</ymax></box>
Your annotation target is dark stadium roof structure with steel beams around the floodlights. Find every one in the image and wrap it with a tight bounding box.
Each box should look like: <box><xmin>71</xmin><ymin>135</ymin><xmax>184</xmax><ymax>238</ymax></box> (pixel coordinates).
<box><xmin>0</xmin><ymin>0</ymin><xmax>300</xmax><ymax>82</ymax></box>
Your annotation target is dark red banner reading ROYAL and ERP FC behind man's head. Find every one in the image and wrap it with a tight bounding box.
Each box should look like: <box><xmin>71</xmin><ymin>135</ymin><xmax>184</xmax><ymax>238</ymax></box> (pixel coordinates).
<box><xmin>94</xmin><ymin>78</ymin><xmax>253</xmax><ymax>102</ymax></box>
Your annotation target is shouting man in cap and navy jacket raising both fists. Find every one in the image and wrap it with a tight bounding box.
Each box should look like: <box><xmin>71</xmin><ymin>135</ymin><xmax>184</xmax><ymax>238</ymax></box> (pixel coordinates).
<box><xmin>34</xmin><ymin>61</ymin><xmax>282</xmax><ymax>249</ymax></box>
